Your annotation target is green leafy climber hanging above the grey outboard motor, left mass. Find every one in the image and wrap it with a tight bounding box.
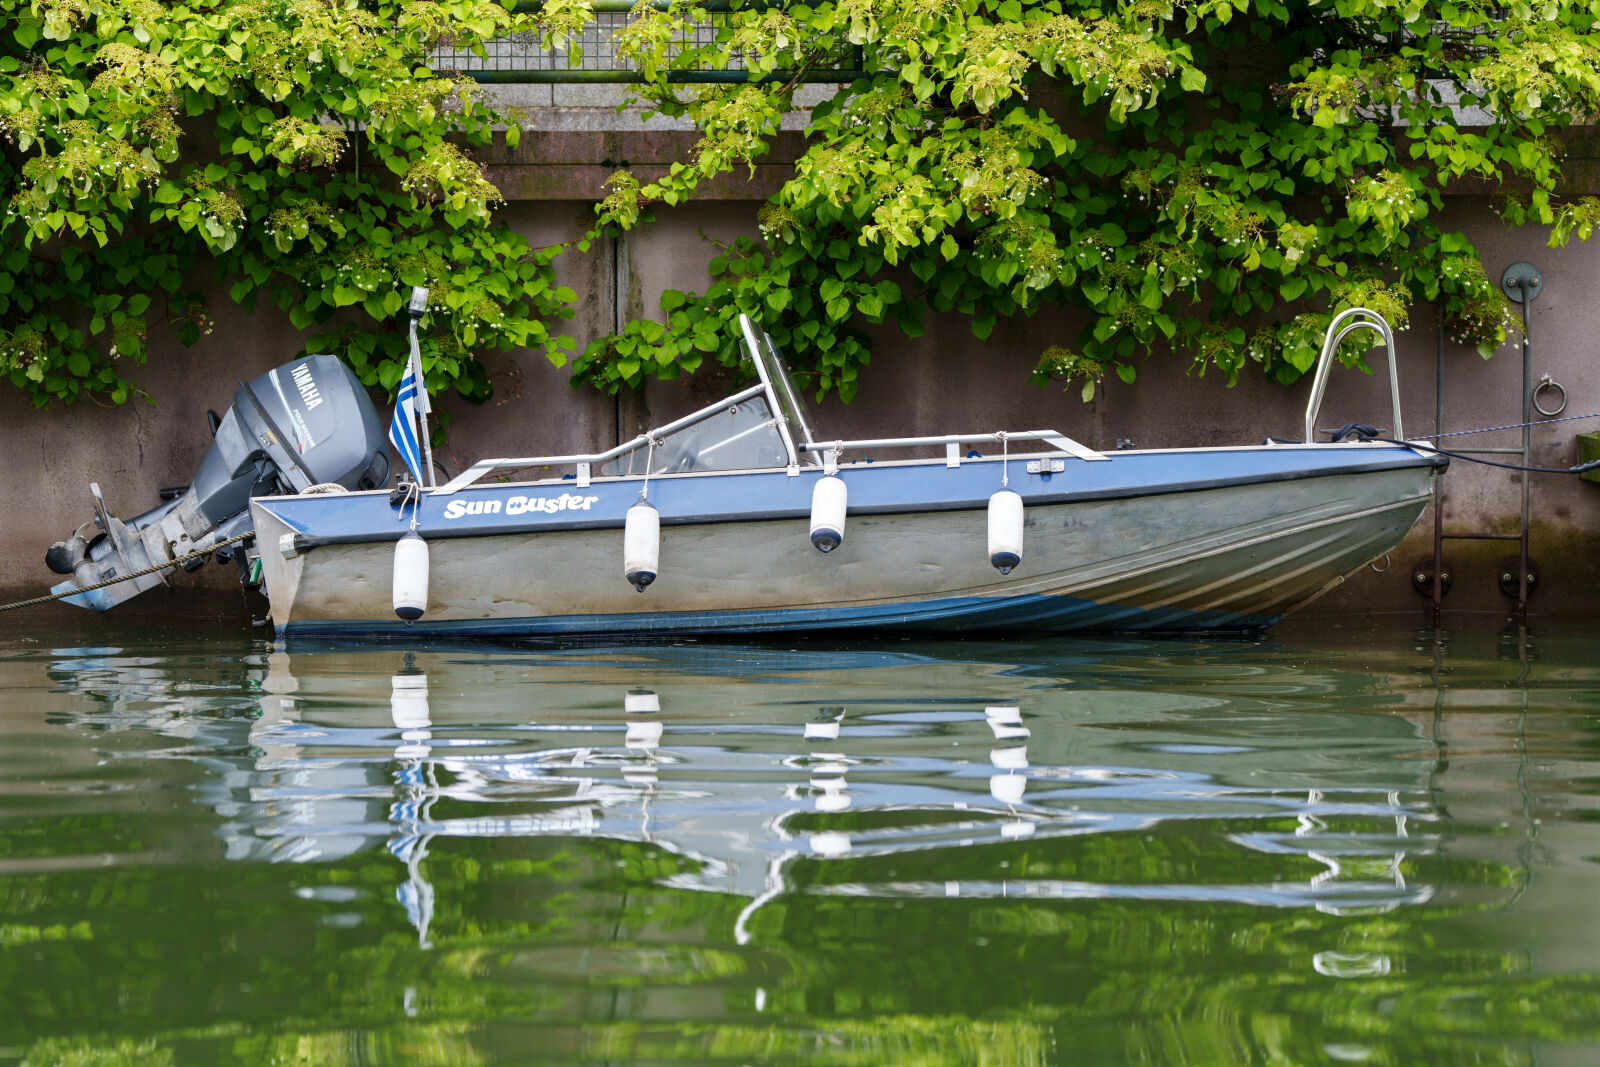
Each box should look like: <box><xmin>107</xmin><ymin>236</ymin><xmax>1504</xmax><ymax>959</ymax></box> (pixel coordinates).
<box><xmin>0</xmin><ymin>0</ymin><xmax>582</xmax><ymax>405</ymax></box>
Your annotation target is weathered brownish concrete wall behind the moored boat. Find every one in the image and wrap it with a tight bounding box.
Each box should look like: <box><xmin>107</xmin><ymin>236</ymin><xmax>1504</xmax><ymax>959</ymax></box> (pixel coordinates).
<box><xmin>0</xmin><ymin>131</ymin><xmax>1600</xmax><ymax>621</ymax></box>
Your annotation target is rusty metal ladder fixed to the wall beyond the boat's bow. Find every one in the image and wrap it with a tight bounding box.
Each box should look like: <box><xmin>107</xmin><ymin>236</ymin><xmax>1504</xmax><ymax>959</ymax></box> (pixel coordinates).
<box><xmin>1413</xmin><ymin>262</ymin><xmax>1544</xmax><ymax>627</ymax></box>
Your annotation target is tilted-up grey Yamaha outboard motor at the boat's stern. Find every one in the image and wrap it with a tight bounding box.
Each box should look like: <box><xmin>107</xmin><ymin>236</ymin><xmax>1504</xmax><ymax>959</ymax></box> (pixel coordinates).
<box><xmin>45</xmin><ymin>355</ymin><xmax>389</xmax><ymax>611</ymax></box>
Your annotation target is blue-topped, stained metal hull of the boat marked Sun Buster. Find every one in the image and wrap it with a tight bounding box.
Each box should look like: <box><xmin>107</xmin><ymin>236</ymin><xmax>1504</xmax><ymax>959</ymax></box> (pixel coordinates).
<box><xmin>253</xmin><ymin>448</ymin><xmax>1437</xmax><ymax>638</ymax></box>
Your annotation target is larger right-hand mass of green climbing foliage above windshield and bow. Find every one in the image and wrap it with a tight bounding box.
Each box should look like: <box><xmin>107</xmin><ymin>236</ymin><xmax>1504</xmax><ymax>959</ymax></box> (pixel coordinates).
<box><xmin>578</xmin><ymin>0</ymin><xmax>1600</xmax><ymax>398</ymax></box>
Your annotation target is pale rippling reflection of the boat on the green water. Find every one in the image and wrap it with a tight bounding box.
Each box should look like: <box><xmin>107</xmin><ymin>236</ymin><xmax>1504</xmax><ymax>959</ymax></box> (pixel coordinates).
<box><xmin>121</xmin><ymin>639</ymin><xmax>1440</xmax><ymax>944</ymax></box>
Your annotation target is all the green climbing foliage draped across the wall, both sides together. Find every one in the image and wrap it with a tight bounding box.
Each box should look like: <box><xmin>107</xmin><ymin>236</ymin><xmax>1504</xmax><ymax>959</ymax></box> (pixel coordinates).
<box><xmin>0</xmin><ymin>0</ymin><xmax>1580</xmax><ymax>415</ymax></box>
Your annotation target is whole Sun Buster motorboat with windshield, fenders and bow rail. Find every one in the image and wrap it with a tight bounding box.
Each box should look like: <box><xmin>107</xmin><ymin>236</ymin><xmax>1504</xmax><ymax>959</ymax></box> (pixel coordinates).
<box><xmin>43</xmin><ymin>309</ymin><xmax>1448</xmax><ymax>640</ymax></box>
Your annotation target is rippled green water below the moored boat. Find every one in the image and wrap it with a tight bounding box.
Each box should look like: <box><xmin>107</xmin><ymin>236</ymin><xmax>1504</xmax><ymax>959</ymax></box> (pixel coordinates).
<box><xmin>0</xmin><ymin>629</ymin><xmax>1600</xmax><ymax>1067</ymax></box>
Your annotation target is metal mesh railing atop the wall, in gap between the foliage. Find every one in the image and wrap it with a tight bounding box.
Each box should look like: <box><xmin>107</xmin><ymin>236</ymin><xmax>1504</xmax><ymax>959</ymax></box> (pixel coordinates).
<box><xmin>434</xmin><ymin>0</ymin><xmax>867</xmax><ymax>85</ymax></box>
